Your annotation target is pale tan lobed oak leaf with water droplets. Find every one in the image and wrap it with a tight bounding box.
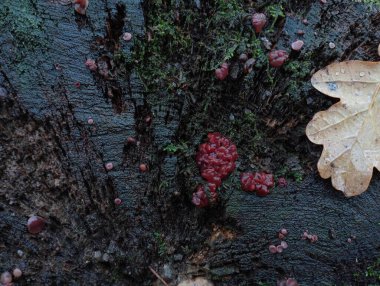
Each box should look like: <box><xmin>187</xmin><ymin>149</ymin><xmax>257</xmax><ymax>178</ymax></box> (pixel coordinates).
<box><xmin>306</xmin><ymin>61</ymin><xmax>380</xmax><ymax>197</ymax></box>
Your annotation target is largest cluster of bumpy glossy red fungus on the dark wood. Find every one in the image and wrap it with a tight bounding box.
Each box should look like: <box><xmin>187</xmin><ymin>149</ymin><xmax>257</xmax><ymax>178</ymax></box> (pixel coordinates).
<box><xmin>193</xmin><ymin>133</ymin><xmax>238</xmax><ymax>206</ymax></box>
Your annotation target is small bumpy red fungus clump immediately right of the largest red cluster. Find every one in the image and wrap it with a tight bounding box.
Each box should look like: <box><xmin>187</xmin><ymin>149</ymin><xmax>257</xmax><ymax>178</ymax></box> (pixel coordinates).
<box><xmin>240</xmin><ymin>173</ymin><xmax>274</xmax><ymax>197</ymax></box>
